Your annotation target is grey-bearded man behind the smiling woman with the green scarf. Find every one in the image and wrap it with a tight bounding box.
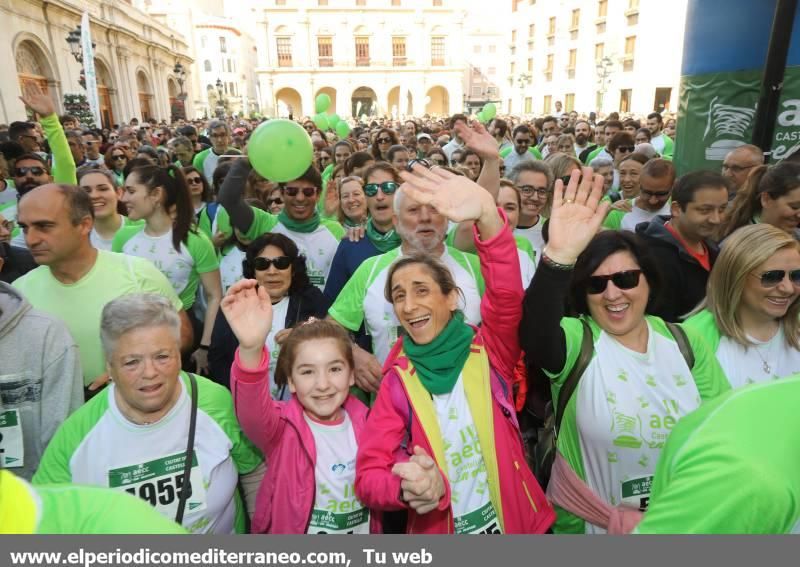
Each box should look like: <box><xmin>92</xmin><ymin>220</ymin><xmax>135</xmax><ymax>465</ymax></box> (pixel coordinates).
<box><xmin>328</xmin><ymin>186</ymin><xmax>483</xmax><ymax>392</ymax></box>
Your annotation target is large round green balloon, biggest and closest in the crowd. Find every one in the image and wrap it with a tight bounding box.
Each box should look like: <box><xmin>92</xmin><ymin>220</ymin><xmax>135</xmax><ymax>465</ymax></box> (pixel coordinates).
<box><xmin>247</xmin><ymin>119</ymin><xmax>314</xmax><ymax>183</ymax></box>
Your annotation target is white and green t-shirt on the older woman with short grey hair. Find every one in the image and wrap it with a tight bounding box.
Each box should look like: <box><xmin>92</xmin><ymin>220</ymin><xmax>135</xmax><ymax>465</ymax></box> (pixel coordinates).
<box><xmin>33</xmin><ymin>372</ymin><xmax>263</xmax><ymax>534</ymax></box>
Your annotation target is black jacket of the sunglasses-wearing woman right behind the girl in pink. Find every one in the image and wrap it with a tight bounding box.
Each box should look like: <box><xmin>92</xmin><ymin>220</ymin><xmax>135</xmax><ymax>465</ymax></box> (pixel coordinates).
<box><xmin>208</xmin><ymin>285</ymin><xmax>330</xmax><ymax>389</ymax></box>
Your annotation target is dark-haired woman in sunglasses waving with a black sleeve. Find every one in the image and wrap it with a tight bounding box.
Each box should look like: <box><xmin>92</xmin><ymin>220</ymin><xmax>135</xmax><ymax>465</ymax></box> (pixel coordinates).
<box><xmin>520</xmin><ymin>168</ymin><xmax>729</xmax><ymax>533</ymax></box>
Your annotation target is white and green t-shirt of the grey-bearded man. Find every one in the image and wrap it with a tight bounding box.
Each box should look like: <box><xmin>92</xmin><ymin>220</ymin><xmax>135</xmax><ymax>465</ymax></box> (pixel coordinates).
<box><xmin>328</xmin><ymin>246</ymin><xmax>484</xmax><ymax>364</ymax></box>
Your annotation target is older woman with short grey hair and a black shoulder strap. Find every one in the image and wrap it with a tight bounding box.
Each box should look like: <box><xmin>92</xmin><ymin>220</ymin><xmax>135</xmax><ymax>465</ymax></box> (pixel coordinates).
<box><xmin>33</xmin><ymin>294</ymin><xmax>265</xmax><ymax>534</ymax></box>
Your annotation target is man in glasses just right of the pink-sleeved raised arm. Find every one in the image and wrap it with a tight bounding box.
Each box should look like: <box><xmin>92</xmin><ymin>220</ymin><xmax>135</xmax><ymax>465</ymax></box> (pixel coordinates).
<box><xmin>508</xmin><ymin>161</ymin><xmax>553</xmax><ymax>258</ymax></box>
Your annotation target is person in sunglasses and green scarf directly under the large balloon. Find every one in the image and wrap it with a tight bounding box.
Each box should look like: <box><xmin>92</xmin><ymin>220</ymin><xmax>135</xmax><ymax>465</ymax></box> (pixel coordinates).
<box><xmin>219</xmin><ymin>158</ymin><xmax>344</xmax><ymax>291</ymax></box>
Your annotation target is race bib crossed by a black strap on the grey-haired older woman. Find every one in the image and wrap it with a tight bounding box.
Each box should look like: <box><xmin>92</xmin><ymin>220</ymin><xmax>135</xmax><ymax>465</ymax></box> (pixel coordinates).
<box><xmin>108</xmin><ymin>453</ymin><xmax>206</xmax><ymax>518</ymax></box>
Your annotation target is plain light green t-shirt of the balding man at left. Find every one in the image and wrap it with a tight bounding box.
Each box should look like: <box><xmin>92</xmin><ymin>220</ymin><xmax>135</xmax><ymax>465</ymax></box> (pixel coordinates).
<box><xmin>13</xmin><ymin>250</ymin><xmax>183</xmax><ymax>385</ymax></box>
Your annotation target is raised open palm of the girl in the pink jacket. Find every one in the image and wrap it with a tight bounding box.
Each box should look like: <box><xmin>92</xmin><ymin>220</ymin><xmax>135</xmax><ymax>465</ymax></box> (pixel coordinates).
<box><xmin>220</xmin><ymin>280</ymin><xmax>272</xmax><ymax>355</ymax></box>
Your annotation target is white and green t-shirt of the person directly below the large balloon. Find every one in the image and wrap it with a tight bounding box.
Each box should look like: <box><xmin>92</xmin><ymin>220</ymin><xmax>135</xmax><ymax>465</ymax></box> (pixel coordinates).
<box><xmin>245</xmin><ymin>209</ymin><xmax>345</xmax><ymax>291</ymax></box>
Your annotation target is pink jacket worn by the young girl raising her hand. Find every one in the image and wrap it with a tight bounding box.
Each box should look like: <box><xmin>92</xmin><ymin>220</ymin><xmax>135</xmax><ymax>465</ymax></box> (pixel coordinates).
<box><xmin>231</xmin><ymin>349</ymin><xmax>382</xmax><ymax>534</ymax></box>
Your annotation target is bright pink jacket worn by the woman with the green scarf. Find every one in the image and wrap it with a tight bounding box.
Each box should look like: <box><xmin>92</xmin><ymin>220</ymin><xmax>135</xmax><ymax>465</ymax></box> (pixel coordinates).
<box><xmin>356</xmin><ymin>220</ymin><xmax>555</xmax><ymax>534</ymax></box>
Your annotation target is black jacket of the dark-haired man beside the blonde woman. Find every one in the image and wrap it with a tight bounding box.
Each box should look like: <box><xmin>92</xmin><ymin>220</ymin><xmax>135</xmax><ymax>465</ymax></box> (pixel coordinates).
<box><xmin>636</xmin><ymin>216</ymin><xmax>719</xmax><ymax>323</ymax></box>
